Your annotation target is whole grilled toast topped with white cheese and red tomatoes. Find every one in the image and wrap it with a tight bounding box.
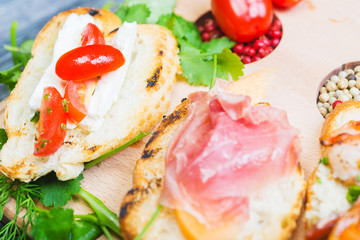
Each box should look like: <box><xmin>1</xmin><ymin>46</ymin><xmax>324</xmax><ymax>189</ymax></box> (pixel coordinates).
<box><xmin>0</xmin><ymin>8</ymin><xmax>178</xmax><ymax>182</ymax></box>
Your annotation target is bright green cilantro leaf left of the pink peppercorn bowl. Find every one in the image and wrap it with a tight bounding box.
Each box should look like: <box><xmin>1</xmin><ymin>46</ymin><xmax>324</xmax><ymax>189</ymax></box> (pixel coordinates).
<box><xmin>157</xmin><ymin>13</ymin><xmax>202</xmax><ymax>47</ymax></box>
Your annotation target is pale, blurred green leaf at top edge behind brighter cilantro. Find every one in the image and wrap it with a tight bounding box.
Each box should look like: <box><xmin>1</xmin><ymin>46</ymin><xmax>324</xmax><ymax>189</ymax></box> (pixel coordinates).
<box><xmin>120</xmin><ymin>0</ymin><xmax>176</xmax><ymax>23</ymax></box>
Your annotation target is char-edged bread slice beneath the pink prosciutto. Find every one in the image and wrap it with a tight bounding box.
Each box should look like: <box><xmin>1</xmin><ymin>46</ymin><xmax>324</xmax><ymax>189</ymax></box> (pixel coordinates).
<box><xmin>120</xmin><ymin>73</ymin><xmax>306</xmax><ymax>240</ymax></box>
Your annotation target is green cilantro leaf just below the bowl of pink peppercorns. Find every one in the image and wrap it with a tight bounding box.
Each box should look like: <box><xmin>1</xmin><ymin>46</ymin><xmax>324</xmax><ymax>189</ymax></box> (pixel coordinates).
<box><xmin>216</xmin><ymin>48</ymin><xmax>244</xmax><ymax>81</ymax></box>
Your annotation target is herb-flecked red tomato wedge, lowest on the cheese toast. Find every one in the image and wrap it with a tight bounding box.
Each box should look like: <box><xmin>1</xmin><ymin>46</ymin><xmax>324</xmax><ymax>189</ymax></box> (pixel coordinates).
<box><xmin>34</xmin><ymin>87</ymin><xmax>66</xmax><ymax>157</ymax></box>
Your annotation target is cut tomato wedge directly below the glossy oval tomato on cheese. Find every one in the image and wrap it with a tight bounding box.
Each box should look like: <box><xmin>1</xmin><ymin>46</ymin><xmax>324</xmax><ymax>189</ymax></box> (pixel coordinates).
<box><xmin>64</xmin><ymin>79</ymin><xmax>97</xmax><ymax>123</ymax></box>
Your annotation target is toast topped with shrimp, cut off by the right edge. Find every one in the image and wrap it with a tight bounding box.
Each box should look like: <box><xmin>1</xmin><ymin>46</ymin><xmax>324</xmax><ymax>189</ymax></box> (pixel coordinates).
<box><xmin>305</xmin><ymin>101</ymin><xmax>360</xmax><ymax>240</ymax></box>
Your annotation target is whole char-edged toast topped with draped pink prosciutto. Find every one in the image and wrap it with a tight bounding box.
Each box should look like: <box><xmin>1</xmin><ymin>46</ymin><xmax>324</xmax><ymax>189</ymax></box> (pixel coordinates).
<box><xmin>120</xmin><ymin>71</ymin><xmax>306</xmax><ymax>240</ymax></box>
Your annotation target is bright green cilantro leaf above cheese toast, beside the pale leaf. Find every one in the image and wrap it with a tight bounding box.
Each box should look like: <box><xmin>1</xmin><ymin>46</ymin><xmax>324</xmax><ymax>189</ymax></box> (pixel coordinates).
<box><xmin>115</xmin><ymin>4</ymin><xmax>150</xmax><ymax>24</ymax></box>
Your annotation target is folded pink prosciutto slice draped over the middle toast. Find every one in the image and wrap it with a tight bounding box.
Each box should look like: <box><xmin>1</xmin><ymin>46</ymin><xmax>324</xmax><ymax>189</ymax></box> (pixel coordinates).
<box><xmin>160</xmin><ymin>92</ymin><xmax>300</xmax><ymax>227</ymax></box>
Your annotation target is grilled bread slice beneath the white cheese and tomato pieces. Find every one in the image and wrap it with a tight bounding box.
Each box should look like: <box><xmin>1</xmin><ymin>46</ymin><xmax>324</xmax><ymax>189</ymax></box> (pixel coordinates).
<box><xmin>0</xmin><ymin>8</ymin><xmax>179</xmax><ymax>182</ymax></box>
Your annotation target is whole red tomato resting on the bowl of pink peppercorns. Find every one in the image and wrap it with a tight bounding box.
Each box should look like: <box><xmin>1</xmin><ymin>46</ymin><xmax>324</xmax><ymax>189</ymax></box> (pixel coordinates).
<box><xmin>211</xmin><ymin>0</ymin><xmax>273</xmax><ymax>42</ymax></box>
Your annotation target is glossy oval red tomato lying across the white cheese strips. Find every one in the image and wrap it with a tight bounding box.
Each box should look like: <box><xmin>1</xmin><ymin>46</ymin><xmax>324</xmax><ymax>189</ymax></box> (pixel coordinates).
<box><xmin>55</xmin><ymin>45</ymin><xmax>125</xmax><ymax>81</ymax></box>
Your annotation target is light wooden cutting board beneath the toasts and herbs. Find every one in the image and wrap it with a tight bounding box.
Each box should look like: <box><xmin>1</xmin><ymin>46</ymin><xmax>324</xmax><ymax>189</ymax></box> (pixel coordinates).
<box><xmin>4</xmin><ymin>0</ymin><xmax>360</xmax><ymax>240</ymax></box>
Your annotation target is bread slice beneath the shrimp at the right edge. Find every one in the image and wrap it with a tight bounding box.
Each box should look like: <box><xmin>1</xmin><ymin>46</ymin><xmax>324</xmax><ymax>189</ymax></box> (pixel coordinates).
<box><xmin>305</xmin><ymin>101</ymin><xmax>360</xmax><ymax>236</ymax></box>
